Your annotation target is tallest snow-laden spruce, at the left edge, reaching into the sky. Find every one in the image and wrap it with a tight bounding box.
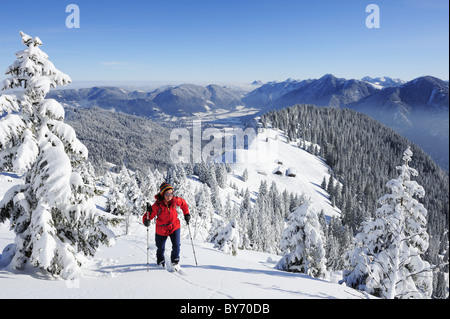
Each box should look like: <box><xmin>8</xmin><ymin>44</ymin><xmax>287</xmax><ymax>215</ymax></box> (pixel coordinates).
<box><xmin>0</xmin><ymin>32</ymin><xmax>114</xmax><ymax>279</ymax></box>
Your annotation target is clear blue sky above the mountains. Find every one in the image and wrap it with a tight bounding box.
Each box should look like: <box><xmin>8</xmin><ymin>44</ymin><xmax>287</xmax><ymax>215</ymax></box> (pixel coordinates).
<box><xmin>0</xmin><ymin>0</ymin><xmax>449</xmax><ymax>83</ymax></box>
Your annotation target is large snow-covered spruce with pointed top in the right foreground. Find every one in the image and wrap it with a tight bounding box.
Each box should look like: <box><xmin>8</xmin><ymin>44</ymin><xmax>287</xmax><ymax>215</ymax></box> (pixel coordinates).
<box><xmin>344</xmin><ymin>148</ymin><xmax>432</xmax><ymax>299</ymax></box>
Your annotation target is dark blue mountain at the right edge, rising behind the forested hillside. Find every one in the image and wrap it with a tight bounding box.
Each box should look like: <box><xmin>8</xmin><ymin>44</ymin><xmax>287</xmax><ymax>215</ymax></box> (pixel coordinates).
<box><xmin>348</xmin><ymin>76</ymin><xmax>449</xmax><ymax>170</ymax></box>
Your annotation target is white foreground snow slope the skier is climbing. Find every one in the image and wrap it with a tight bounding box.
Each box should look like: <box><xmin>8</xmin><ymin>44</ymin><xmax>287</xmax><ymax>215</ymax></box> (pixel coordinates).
<box><xmin>0</xmin><ymin>173</ymin><xmax>368</xmax><ymax>299</ymax></box>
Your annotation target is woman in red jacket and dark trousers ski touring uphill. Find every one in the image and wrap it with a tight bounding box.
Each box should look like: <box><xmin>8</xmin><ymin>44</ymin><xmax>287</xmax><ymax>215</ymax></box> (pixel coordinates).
<box><xmin>142</xmin><ymin>182</ymin><xmax>191</xmax><ymax>267</ymax></box>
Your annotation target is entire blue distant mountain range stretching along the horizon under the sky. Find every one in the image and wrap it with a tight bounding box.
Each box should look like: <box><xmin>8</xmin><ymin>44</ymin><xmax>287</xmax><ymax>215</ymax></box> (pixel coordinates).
<box><xmin>47</xmin><ymin>74</ymin><xmax>449</xmax><ymax>169</ymax></box>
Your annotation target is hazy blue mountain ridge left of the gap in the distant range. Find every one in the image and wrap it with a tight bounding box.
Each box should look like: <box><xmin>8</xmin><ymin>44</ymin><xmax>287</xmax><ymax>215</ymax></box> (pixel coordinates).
<box><xmin>47</xmin><ymin>84</ymin><xmax>242</xmax><ymax>117</ymax></box>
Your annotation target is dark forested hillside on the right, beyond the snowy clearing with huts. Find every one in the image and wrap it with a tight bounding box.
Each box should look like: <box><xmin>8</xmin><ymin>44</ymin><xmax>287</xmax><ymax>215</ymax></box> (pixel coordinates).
<box><xmin>261</xmin><ymin>104</ymin><xmax>449</xmax><ymax>270</ymax></box>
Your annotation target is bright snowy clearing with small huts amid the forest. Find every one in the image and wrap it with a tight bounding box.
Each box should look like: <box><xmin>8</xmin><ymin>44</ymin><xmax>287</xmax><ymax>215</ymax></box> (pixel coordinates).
<box><xmin>215</xmin><ymin>129</ymin><xmax>341</xmax><ymax>217</ymax></box>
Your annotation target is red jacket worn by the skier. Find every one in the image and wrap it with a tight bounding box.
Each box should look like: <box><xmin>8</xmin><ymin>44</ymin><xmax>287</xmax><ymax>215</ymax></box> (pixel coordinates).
<box><xmin>142</xmin><ymin>197</ymin><xmax>189</xmax><ymax>236</ymax></box>
